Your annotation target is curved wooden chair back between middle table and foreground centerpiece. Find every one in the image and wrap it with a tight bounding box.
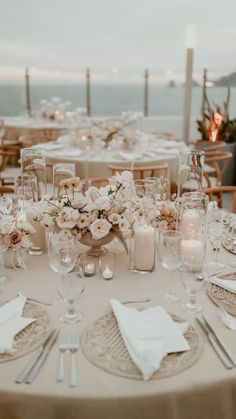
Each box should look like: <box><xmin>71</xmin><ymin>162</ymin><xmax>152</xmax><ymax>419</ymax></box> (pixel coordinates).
<box><xmin>108</xmin><ymin>163</ymin><xmax>169</xmax><ymax>179</ymax></box>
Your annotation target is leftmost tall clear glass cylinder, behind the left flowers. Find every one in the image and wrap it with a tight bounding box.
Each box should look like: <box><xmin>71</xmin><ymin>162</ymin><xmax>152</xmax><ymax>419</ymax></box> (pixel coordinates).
<box><xmin>21</xmin><ymin>148</ymin><xmax>47</xmax><ymax>200</ymax></box>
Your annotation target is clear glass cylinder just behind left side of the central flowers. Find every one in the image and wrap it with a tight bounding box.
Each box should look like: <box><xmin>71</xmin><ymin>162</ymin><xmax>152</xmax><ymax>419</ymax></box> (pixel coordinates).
<box><xmin>53</xmin><ymin>163</ymin><xmax>75</xmax><ymax>199</ymax></box>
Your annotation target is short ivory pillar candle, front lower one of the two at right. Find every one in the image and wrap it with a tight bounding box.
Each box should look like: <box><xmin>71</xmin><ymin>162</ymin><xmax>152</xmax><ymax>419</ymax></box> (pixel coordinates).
<box><xmin>181</xmin><ymin>239</ymin><xmax>204</xmax><ymax>268</ymax></box>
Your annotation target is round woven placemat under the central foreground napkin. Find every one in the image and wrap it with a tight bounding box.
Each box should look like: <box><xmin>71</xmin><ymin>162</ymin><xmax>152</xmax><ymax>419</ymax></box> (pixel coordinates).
<box><xmin>80</xmin><ymin>311</ymin><xmax>203</xmax><ymax>380</ymax></box>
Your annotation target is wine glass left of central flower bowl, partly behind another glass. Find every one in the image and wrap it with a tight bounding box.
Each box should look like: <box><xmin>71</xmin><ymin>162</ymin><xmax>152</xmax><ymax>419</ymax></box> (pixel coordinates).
<box><xmin>47</xmin><ymin>233</ymin><xmax>77</xmax><ymax>316</ymax></box>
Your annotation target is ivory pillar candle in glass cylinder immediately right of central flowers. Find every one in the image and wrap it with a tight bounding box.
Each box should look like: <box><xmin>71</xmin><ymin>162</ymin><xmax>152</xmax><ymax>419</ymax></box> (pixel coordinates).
<box><xmin>134</xmin><ymin>225</ymin><xmax>155</xmax><ymax>271</ymax></box>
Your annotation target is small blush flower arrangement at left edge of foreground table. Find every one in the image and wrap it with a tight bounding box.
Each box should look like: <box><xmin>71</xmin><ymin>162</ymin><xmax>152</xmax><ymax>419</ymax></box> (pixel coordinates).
<box><xmin>0</xmin><ymin>210</ymin><xmax>35</xmax><ymax>268</ymax></box>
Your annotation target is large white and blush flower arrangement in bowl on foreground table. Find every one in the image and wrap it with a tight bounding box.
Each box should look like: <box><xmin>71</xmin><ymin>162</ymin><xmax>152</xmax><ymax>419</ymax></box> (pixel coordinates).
<box><xmin>37</xmin><ymin>172</ymin><xmax>133</xmax><ymax>253</ymax></box>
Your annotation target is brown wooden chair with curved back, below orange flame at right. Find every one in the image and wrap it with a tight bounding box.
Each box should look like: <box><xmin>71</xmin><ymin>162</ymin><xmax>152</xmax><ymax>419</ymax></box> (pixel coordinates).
<box><xmin>204</xmin><ymin>150</ymin><xmax>233</xmax><ymax>187</ymax></box>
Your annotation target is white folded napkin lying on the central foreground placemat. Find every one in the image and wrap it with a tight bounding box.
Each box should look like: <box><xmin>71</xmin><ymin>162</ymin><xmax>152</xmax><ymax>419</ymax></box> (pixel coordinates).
<box><xmin>111</xmin><ymin>300</ymin><xmax>190</xmax><ymax>380</ymax></box>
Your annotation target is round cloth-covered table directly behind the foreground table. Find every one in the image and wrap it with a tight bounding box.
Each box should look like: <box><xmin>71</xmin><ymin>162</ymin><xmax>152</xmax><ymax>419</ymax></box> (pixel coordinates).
<box><xmin>34</xmin><ymin>133</ymin><xmax>187</xmax><ymax>180</ymax></box>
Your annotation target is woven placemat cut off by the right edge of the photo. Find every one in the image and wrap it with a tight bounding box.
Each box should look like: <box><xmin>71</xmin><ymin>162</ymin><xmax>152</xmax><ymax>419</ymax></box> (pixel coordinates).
<box><xmin>207</xmin><ymin>272</ymin><xmax>236</xmax><ymax>316</ymax></box>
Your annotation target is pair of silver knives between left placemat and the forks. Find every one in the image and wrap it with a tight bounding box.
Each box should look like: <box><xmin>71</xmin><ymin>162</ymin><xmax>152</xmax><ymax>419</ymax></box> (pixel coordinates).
<box><xmin>15</xmin><ymin>329</ymin><xmax>58</xmax><ymax>384</ymax></box>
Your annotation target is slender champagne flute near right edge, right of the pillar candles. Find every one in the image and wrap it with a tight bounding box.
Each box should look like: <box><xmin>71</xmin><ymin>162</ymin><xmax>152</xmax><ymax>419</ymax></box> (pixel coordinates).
<box><xmin>207</xmin><ymin>208</ymin><xmax>230</xmax><ymax>274</ymax></box>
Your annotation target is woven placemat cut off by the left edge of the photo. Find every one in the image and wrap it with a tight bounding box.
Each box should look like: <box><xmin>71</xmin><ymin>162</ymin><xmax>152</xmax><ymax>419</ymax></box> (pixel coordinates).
<box><xmin>0</xmin><ymin>300</ymin><xmax>50</xmax><ymax>362</ymax></box>
